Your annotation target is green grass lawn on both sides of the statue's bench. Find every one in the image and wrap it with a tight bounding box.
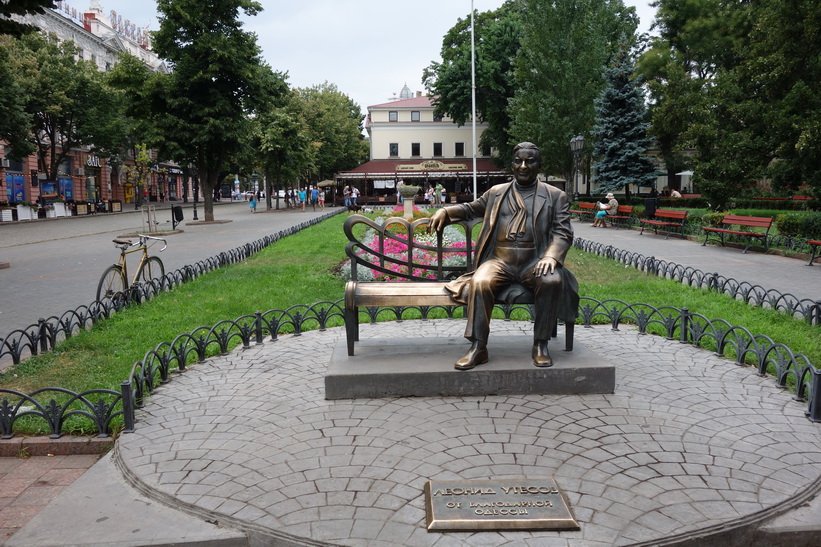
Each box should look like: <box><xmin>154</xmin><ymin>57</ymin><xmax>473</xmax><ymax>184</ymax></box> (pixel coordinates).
<box><xmin>0</xmin><ymin>215</ymin><xmax>821</xmax><ymax>430</ymax></box>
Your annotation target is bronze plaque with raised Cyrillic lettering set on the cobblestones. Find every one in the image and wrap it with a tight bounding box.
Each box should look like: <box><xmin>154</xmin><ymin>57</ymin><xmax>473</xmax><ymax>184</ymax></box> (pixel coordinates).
<box><xmin>425</xmin><ymin>479</ymin><xmax>579</xmax><ymax>532</ymax></box>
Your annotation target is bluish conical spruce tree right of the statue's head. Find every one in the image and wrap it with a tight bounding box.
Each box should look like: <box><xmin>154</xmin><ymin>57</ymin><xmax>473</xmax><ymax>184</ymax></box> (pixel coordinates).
<box><xmin>592</xmin><ymin>44</ymin><xmax>656</xmax><ymax>199</ymax></box>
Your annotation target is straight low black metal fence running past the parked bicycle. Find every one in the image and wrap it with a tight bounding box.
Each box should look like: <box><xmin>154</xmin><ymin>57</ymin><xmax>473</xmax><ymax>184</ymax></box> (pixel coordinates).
<box><xmin>0</xmin><ymin>208</ymin><xmax>344</xmax><ymax>365</ymax></box>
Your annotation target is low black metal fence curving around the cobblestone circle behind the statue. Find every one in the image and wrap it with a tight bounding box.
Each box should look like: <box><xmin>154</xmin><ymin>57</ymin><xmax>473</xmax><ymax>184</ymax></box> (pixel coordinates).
<box><xmin>0</xmin><ymin>297</ymin><xmax>821</xmax><ymax>438</ymax></box>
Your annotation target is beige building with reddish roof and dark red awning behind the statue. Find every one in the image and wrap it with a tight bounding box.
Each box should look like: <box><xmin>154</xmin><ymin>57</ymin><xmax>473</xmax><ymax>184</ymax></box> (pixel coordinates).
<box><xmin>336</xmin><ymin>85</ymin><xmax>506</xmax><ymax>204</ymax></box>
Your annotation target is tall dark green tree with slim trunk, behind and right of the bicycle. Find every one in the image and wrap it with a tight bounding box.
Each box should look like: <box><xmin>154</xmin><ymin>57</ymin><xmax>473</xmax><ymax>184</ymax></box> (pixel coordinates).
<box><xmin>147</xmin><ymin>0</ymin><xmax>276</xmax><ymax>221</ymax></box>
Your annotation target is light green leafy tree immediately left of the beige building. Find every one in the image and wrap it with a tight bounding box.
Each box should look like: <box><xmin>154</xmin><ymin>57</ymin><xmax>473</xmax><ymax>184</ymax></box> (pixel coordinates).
<box><xmin>297</xmin><ymin>82</ymin><xmax>368</xmax><ymax>181</ymax></box>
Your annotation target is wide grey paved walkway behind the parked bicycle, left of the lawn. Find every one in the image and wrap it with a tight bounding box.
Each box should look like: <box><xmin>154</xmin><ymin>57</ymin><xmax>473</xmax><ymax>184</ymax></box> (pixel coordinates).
<box><xmin>0</xmin><ymin>201</ymin><xmax>336</xmax><ymax>339</ymax></box>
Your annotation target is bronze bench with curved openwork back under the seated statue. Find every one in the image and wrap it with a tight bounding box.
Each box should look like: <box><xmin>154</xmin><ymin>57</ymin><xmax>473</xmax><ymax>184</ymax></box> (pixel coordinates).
<box><xmin>343</xmin><ymin>215</ymin><xmax>579</xmax><ymax>355</ymax></box>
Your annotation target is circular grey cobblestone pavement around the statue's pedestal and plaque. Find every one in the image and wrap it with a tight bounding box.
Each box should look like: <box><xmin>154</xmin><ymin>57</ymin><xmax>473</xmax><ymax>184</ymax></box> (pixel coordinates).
<box><xmin>115</xmin><ymin>320</ymin><xmax>821</xmax><ymax>546</ymax></box>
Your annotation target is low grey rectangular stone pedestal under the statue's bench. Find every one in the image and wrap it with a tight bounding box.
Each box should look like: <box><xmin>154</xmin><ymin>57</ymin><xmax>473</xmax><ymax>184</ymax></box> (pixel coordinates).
<box><xmin>325</xmin><ymin>333</ymin><xmax>616</xmax><ymax>399</ymax></box>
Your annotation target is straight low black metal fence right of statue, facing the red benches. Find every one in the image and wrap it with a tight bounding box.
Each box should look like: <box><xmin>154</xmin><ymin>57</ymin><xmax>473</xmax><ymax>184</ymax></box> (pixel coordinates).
<box><xmin>573</xmin><ymin>237</ymin><xmax>821</xmax><ymax>326</ymax></box>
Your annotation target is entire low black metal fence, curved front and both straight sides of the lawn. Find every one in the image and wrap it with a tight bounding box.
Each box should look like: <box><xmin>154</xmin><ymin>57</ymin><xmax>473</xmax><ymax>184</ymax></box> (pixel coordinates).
<box><xmin>0</xmin><ymin>220</ymin><xmax>821</xmax><ymax>438</ymax></box>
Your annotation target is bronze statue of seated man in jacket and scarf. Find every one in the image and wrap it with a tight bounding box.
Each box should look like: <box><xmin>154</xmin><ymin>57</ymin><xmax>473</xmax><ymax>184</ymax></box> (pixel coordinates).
<box><xmin>428</xmin><ymin>142</ymin><xmax>578</xmax><ymax>370</ymax></box>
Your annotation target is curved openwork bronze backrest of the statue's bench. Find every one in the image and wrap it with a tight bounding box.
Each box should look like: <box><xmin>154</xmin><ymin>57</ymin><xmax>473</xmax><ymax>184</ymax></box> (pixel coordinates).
<box><xmin>343</xmin><ymin>215</ymin><xmax>482</xmax><ymax>281</ymax></box>
